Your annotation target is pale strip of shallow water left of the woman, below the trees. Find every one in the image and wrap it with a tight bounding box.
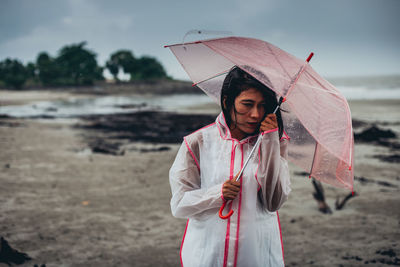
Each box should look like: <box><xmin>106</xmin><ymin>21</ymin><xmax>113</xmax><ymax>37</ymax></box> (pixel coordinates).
<box><xmin>0</xmin><ymin>94</ymin><xmax>211</xmax><ymax>118</ymax></box>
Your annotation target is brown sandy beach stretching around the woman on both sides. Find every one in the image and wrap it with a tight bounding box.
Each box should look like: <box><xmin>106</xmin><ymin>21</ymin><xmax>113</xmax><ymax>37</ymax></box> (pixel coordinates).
<box><xmin>0</xmin><ymin>91</ymin><xmax>400</xmax><ymax>266</ymax></box>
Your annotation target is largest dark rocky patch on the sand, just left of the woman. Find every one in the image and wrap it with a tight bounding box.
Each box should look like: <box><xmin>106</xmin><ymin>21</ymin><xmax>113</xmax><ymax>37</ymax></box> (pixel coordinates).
<box><xmin>75</xmin><ymin>111</ymin><xmax>216</xmax><ymax>155</ymax></box>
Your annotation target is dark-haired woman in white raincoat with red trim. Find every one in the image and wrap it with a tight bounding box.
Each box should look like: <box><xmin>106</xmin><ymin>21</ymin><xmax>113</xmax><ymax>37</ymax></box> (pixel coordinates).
<box><xmin>170</xmin><ymin>67</ymin><xmax>290</xmax><ymax>266</ymax></box>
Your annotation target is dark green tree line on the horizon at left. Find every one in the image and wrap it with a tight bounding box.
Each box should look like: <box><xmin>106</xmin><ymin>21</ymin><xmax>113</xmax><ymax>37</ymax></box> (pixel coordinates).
<box><xmin>0</xmin><ymin>42</ymin><xmax>169</xmax><ymax>89</ymax></box>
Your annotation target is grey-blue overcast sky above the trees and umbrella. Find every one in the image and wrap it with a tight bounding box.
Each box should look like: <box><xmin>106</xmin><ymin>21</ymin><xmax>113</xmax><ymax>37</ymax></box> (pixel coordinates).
<box><xmin>0</xmin><ymin>0</ymin><xmax>400</xmax><ymax>79</ymax></box>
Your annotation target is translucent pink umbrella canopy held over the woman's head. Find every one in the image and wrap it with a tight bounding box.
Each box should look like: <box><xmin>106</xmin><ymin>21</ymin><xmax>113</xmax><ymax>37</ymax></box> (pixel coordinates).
<box><xmin>166</xmin><ymin>37</ymin><xmax>354</xmax><ymax>190</ymax></box>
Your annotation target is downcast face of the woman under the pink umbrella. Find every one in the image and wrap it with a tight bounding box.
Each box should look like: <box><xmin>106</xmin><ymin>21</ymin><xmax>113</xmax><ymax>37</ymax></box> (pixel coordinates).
<box><xmin>230</xmin><ymin>88</ymin><xmax>266</xmax><ymax>140</ymax></box>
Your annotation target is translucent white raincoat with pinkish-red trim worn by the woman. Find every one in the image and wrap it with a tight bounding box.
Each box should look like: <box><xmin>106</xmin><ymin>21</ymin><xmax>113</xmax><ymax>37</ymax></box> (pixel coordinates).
<box><xmin>170</xmin><ymin>113</ymin><xmax>291</xmax><ymax>267</ymax></box>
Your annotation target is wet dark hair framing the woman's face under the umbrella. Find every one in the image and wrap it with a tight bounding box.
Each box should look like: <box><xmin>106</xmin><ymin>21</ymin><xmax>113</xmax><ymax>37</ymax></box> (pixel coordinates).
<box><xmin>221</xmin><ymin>66</ymin><xmax>283</xmax><ymax>138</ymax></box>
